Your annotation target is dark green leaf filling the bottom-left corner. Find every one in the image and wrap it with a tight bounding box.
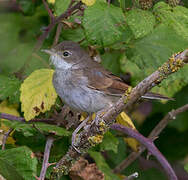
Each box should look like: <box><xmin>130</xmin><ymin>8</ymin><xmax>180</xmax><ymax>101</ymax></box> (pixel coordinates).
<box><xmin>0</xmin><ymin>146</ymin><xmax>37</xmax><ymax>180</ymax></box>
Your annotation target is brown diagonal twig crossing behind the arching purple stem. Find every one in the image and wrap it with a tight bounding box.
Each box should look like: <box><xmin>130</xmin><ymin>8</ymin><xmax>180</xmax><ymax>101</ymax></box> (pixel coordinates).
<box><xmin>113</xmin><ymin>104</ymin><xmax>188</xmax><ymax>173</ymax></box>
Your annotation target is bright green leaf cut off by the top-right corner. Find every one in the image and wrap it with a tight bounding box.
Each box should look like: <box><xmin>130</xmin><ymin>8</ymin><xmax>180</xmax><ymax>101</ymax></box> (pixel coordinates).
<box><xmin>153</xmin><ymin>2</ymin><xmax>188</xmax><ymax>38</ymax></box>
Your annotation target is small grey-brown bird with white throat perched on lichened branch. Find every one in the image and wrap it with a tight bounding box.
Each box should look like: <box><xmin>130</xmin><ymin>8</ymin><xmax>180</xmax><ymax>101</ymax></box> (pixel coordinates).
<box><xmin>43</xmin><ymin>41</ymin><xmax>172</xmax><ymax>150</ymax></box>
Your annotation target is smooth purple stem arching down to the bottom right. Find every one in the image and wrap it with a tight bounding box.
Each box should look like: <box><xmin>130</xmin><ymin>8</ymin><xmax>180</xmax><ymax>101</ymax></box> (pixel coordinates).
<box><xmin>111</xmin><ymin>124</ymin><xmax>177</xmax><ymax>180</ymax></box>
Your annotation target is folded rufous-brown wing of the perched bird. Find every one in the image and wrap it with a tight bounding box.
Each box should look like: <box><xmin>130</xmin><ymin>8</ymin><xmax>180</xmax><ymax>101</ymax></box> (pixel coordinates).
<box><xmin>84</xmin><ymin>67</ymin><xmax>129</xmax><ymax>96</ymax></box>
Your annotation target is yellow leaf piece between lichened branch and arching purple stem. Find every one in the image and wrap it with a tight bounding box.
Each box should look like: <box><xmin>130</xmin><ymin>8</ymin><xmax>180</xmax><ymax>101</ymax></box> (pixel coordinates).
<box><xmin>116</xmin><ymin>112</ymin><xmax>136</xmax><ymax>129</ymax></box>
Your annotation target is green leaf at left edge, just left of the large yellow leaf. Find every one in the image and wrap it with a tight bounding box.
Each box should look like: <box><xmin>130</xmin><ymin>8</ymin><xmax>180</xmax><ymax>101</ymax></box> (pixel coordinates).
<box><xmin>0</xmin><ymin>75</ymin><xmax>21</xmax><ymax>103</ymax></box>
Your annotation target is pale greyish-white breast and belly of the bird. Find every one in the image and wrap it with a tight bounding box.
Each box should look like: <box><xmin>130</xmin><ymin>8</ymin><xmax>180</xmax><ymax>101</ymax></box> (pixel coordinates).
<box><xmin>53</xmin><ymin>71</ymin><xmax>111</xmax><ymax>113</ymax></box>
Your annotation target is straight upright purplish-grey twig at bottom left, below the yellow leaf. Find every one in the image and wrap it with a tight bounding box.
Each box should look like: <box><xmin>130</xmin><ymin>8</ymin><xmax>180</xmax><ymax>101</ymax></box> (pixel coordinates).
<box><xmin>39</xmin><ymin>136</ymin><xmax>54</xmax><ymax>180</ymax></box>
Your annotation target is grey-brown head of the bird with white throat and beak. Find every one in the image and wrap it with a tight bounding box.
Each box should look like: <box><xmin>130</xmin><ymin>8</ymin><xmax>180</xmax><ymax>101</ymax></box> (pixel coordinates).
<box><xmin>43</xmin><ymin>41</ymin><xmax>90</xmax><ymax>70</ymax></box>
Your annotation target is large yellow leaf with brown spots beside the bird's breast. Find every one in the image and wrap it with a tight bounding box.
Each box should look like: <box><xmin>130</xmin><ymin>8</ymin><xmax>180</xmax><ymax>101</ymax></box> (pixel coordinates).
<box><xmin>20</xmin><ymin>69</ymin><xmax>57</xmax><ymax>121</ymax></box>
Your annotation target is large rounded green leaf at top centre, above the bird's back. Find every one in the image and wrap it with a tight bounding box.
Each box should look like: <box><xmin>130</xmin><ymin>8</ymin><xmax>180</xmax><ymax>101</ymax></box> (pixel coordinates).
<box><xmin>83</xmin><ymin>2</ymin><xmax>125</xmax><ymax>46</ymax></box>
